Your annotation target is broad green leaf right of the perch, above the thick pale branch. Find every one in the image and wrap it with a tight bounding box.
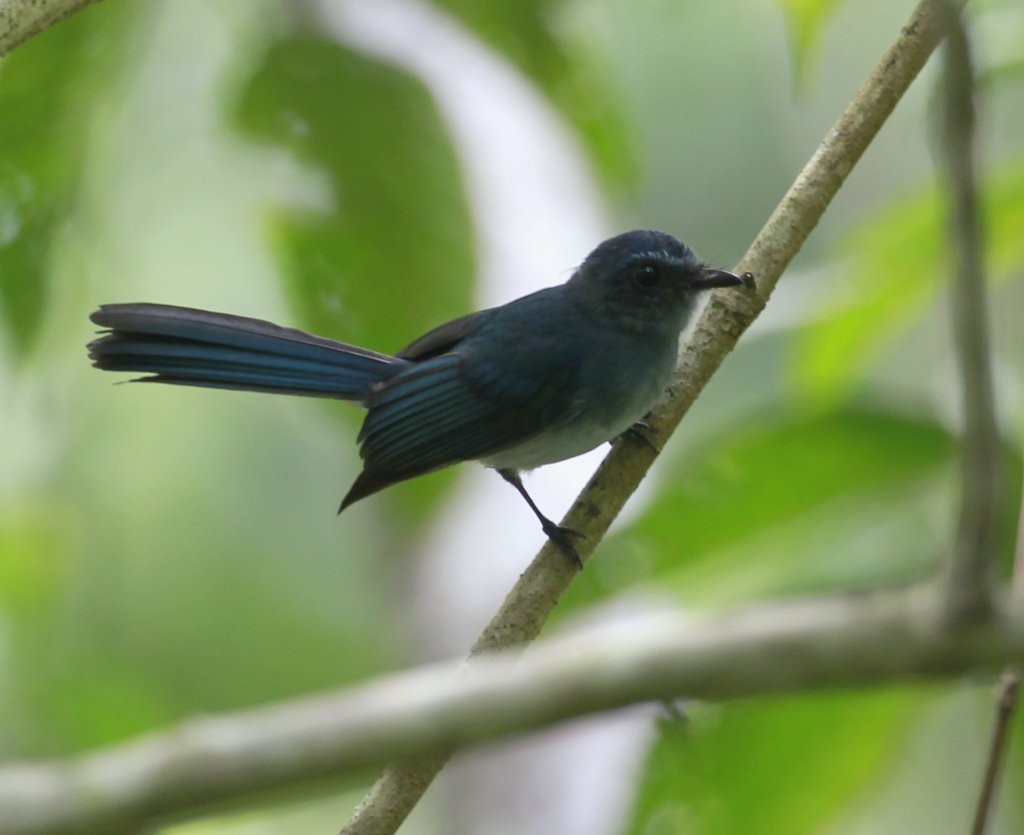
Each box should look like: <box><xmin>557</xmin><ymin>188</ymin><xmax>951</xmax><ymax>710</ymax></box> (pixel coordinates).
<box><xmin>560</xmin><ymin>410</ymin><xmax>954</xmax><ymax>612</ymax></box>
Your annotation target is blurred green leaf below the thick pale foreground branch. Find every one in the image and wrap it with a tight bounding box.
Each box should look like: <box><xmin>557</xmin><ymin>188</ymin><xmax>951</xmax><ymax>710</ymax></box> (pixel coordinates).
<box><xmin>628</xmin><ymin>691</ymin><xmax>929</xmax><ymax>835</ymax></box>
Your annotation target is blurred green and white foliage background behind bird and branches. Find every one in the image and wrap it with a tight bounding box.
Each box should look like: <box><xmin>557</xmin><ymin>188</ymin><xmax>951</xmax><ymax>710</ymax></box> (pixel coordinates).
<box><xmin>0</xmin><ymin>0</ymin><xmax>1024</xmax><ymax>835</ymax></box>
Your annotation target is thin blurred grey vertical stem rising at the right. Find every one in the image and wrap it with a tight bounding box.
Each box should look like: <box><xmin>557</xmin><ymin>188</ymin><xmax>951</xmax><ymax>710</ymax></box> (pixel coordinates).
<box><xmin>940</xmin><ymin>2</ymin><xmax>999</xmax><ymax>625</ymax></box>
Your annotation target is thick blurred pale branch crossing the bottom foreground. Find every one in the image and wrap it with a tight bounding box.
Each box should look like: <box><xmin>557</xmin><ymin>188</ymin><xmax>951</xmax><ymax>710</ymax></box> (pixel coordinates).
<box><xmin>0</xmin><ymin>590</ymin><xmax>1024</xmax><ymax>835</ymax></box>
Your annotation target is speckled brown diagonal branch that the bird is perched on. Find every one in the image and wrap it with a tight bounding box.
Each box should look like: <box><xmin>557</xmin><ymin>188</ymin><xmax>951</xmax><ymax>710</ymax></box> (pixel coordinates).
<box><xmin>342</xmin><ymin>0</ymin><xmax>966</xmax><ymax>835</ymax></box>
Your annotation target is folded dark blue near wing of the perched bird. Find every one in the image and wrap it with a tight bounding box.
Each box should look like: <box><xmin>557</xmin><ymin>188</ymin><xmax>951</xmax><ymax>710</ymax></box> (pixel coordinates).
<box><xmin>341</xmin><ymin>353</ymin><xmax>571</xmax><ymax>509</ymax></box>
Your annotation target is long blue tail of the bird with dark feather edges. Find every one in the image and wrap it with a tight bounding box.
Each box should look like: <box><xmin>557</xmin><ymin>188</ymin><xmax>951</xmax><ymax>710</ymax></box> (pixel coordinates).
<box><xmin>89</xmin><ymin>304</ymin><xmax>409</xmax><ymax>401</ymax></box>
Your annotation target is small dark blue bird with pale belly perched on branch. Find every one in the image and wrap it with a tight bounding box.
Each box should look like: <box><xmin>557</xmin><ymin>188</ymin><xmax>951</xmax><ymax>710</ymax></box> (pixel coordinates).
<box><xmin>88</xmin><ymin>229</ymin><xmax>746</xmax><ymax>567</ymax></box>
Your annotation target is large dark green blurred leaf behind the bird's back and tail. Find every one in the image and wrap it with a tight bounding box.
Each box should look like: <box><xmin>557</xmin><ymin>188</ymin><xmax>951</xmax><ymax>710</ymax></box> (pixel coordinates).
<box><xmin>238</xmin><ymin>37</ymin><xmax>475</xmax><ymax>522</ymax></box>
